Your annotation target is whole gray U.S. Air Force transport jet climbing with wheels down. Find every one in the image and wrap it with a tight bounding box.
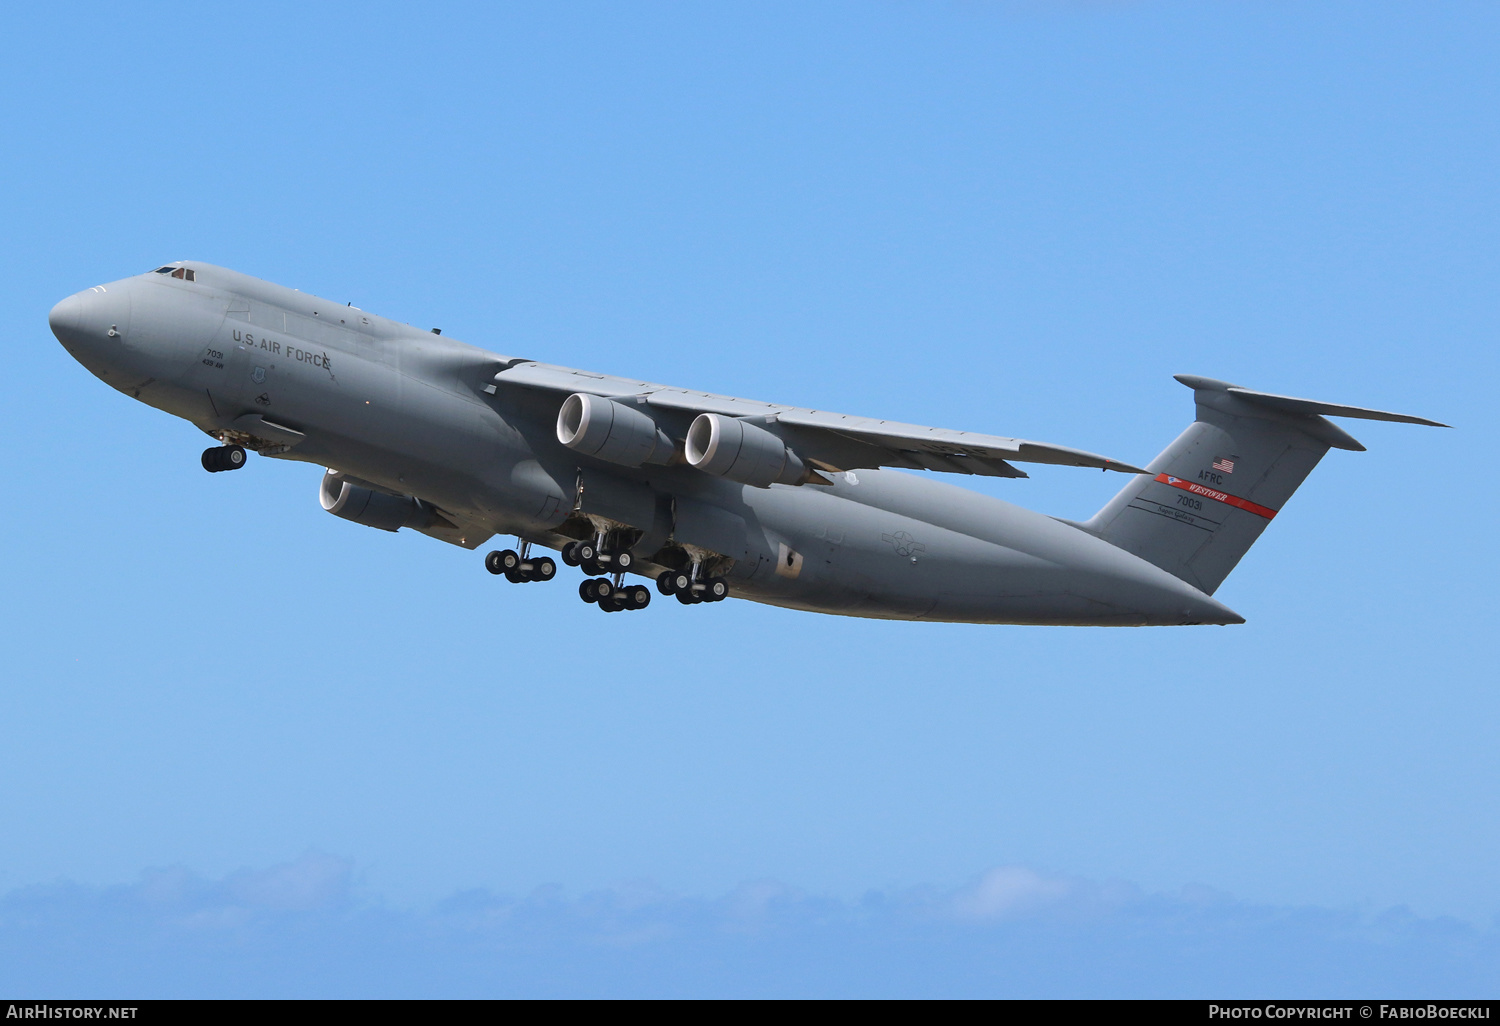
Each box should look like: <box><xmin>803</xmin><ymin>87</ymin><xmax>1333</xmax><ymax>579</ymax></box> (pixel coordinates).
<box><xmin>50</xmin><ymin>261</ymin><xmax>1445</xmax><ymax>626</ymax></box>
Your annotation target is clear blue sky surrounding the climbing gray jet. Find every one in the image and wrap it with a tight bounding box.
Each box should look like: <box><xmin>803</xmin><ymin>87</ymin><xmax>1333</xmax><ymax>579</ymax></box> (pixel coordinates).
<box><xmin>0</xmin><ymin>3</ymin><xmax>1500</xmax><ymax>993</ymax></box>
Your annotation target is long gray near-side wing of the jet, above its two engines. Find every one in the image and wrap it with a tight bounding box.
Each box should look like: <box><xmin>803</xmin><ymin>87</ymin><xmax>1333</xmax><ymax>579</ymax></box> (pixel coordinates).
<box><xmin>494</xmin><ymin>362</ymin><xmax>1146</xmax><ymax>477</ymax></box>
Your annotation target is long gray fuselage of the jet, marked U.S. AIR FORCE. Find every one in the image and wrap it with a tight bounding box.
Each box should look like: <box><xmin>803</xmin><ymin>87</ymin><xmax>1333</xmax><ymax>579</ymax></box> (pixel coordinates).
<box><xmin>51</xmin><ymin>263</ymin><xmax>1242</xmax><ymax>626</ymax></box>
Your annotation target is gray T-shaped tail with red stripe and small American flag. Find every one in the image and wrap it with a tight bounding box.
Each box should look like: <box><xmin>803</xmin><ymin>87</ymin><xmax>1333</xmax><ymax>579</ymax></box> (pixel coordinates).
<box><xmin>1082</xmin><ymin>374</ymin><xmax>1448</xmax><ymax>594</ymax></box>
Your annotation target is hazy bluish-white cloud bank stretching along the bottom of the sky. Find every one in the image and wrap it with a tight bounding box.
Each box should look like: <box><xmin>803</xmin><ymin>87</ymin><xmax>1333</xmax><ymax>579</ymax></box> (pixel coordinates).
<box><xmin>0</xmin><ymin>852</ymin><xmax>1500</xmax><ymax>998</ymax></box>
